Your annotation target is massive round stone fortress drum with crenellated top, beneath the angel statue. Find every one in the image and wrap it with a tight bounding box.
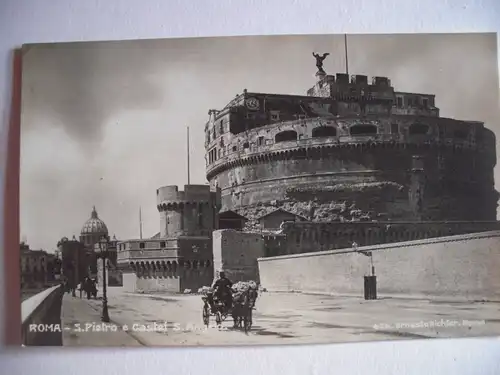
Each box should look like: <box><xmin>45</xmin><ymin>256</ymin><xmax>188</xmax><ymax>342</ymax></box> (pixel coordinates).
<box><xmin>205</xmin><ymin>70</ymin><xmax>498</xmax><ymax>222</ymax></box>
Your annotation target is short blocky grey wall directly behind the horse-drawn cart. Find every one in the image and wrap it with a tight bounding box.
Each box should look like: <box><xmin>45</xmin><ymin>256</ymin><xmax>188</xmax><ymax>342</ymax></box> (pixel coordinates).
<box><xmin>213</xmin><ymin>229</ymin><xmax>265</xmax><ymax>282</ymax></box>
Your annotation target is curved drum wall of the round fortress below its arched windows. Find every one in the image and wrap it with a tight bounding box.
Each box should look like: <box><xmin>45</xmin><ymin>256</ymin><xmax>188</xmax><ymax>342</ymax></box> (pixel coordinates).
<box><xmin>212</xmin><ymin>140</ymin><xmax>498</xmax><ymax>220</ymax></box>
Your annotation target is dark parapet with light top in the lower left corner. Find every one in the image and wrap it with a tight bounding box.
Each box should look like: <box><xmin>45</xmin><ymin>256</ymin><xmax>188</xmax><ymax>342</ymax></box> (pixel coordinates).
<box><xmin>21</xmin><ymin>285</ymin><xmax>64</xmax><ymax>346</ymax></box>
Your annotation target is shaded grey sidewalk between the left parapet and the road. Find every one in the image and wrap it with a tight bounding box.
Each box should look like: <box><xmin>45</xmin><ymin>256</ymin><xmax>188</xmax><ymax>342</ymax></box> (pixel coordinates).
<box><xmin>61</xmin><ymin>294</ymin><xmax>142</xmax><ymax>347</ymax></box>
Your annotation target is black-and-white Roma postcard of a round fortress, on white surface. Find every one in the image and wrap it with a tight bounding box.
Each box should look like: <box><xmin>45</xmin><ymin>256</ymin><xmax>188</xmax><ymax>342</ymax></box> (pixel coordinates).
<box><xmin>19</xmin><ymin>33</ymin><xmax>500</xmax><ymax>346</ymax></box>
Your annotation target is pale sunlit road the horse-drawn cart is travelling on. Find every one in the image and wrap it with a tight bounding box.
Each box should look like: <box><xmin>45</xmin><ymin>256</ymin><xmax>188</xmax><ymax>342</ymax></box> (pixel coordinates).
<box><xmin>63</xmin><ymin>288</ymin><xmax>500</xmax><ymax>346</ymax></box>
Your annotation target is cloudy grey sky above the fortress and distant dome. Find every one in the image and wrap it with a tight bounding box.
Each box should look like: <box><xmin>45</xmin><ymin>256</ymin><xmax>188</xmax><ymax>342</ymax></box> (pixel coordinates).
<box><xmin>20</xmin><ymin>33</ymin><xmax>500</xmax><ymax>252</ymax></box>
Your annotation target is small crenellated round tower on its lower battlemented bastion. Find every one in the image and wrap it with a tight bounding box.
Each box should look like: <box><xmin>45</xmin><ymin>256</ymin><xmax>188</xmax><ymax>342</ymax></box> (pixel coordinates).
<box><xmin>117</xmin><ymin>185</ymin><xmax>220</xmax><ymax>292</ymax></box>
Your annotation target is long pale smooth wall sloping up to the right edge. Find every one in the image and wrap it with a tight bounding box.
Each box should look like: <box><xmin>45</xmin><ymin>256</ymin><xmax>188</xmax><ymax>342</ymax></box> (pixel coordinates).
<box><xmin>258</xmin><ymin>231</ymin><xmax>500</xmax><ymax>300</ymax></box>
